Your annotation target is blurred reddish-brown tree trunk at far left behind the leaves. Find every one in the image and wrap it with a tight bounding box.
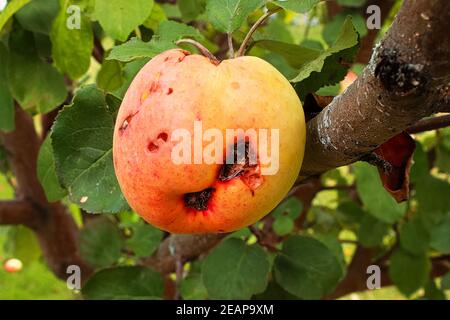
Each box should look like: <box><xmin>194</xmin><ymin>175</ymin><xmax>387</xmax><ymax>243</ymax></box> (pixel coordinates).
<box><xmin>0</xmin><ymin>105</ymin><xmax>92</xmax><ymax>279</ymax></box>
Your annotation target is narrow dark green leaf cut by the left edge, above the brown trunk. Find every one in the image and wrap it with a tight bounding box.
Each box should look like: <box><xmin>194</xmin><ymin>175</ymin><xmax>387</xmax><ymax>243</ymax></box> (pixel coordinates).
<box><xmin>0</xmin><ymin>42</ymin><xmax>15</xmax><ymax>132</ymax></box>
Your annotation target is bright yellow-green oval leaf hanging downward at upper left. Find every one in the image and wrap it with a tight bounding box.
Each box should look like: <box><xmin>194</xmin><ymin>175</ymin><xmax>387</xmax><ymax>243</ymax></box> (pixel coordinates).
<box><xmin>50</xmin><ymin>0</ymin><xmax>94</xmax><ymax>79</ymax></box>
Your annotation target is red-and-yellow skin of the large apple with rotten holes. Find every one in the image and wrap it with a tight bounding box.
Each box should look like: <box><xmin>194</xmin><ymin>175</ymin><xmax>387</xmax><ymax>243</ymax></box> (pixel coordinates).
<box><xmin>113</xmin><ymin>49</ymin><xmax>306</xmax><ymax>234</ymax></box>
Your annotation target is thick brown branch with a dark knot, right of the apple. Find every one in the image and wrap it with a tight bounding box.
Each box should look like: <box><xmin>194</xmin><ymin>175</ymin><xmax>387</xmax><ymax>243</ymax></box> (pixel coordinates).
<box><xmin>300</xmin><ymin>0</ymin><xmax>450</xmax><ymax>179</ymax></box>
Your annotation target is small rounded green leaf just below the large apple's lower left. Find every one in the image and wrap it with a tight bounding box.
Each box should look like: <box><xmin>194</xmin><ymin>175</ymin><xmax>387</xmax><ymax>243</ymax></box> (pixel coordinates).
<box><xmin>127</xmin><ymin>223</ymin><xmax>163</xmax><ymax>257</ymax></box>
